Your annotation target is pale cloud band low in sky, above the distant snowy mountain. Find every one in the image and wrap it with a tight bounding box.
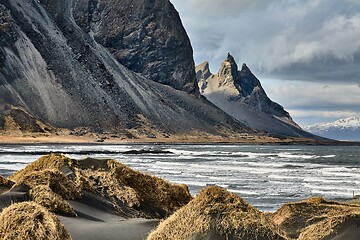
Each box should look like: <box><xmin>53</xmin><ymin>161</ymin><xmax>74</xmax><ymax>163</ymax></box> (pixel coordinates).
<box><xmin>262</xmin><ymin>80</ymin><xmax>360</xmax><ymax>126</ymax></box>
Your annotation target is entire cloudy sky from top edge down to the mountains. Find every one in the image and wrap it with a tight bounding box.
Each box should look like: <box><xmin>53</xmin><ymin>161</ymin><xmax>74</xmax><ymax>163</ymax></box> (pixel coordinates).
<box><xmin>171</xmin><ymin>0</ymin><xmax>360</xmax><ymax>127</ymax></box>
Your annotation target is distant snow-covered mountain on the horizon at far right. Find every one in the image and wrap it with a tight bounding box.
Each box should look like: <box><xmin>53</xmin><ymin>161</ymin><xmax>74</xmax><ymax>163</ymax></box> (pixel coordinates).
<box><xmin>305</xmin><ymin>117</ymin><xmax>360</xmax><ymax>141</ymax></box>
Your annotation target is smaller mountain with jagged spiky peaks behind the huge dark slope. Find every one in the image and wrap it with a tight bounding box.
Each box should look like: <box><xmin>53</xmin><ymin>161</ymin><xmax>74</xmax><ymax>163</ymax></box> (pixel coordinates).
<box><xmin>196</xmin><ymin>54</ymin><xmax>316</xmax><ymax>138</ymax></box>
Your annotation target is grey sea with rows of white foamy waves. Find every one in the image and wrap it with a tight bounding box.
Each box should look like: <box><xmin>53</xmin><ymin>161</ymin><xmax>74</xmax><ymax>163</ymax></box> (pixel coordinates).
<box><xmin>0</xmin><ymin>144</ymin><xmax>360</xmax><ymax>211</ymax></box>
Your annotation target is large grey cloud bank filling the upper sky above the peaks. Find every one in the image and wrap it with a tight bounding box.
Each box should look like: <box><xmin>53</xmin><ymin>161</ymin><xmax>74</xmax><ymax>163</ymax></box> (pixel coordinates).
<box><xmin>172</xmin><ymin>0</ymin><xmax>360</xmax><ymax>84</ymax></box>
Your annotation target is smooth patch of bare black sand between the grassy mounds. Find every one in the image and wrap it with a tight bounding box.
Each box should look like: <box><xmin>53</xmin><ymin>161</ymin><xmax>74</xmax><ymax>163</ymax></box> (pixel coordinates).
<box><xmin>59</xmin><ymin>193</ymin><xmax>159</xmax><ymax>240</ymax></box>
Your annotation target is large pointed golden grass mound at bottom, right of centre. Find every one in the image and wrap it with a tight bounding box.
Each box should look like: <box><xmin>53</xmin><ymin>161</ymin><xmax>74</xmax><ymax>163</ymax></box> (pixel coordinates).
<box><xmin>147</xmin><ymin>186</ymin><xmax>286</xmax><ymax>240</ymax></box>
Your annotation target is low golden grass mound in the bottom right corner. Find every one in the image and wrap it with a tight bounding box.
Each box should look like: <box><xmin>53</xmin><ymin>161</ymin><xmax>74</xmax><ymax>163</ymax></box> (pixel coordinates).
<box><xmin>271</xmin><ymin>197</ymin><xmax>360</xmax><ymax>240</ymax></box>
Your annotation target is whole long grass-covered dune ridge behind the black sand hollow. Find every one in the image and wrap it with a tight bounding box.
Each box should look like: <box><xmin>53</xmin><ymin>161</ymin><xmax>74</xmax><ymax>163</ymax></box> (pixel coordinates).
<box><xmin>6</xmin><ymin>154</ymin><xmax>192</xmax><ymax>218</ymax></box>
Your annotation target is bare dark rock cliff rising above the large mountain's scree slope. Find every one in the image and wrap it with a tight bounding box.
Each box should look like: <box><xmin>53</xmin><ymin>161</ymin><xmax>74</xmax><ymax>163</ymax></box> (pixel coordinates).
<box><xmin>74</xmin><ymin>0</ymin><xmax>198</xmax><ymax>93</ymax></box>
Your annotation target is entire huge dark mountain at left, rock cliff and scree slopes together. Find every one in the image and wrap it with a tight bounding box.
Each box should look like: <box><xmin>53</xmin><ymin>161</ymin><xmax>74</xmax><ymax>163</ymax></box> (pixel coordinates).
<box><xmin>0</xmin><ymin>0</ymin><xmax>253</xmax><ymax>137</ymax></box>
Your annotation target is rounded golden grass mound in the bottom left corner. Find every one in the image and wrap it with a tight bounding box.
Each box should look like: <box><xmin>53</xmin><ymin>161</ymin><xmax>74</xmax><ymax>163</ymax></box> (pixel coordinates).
<box><xmin>0</xmin><ymin>202</ymin><xmax>71</xmax><ymax>240</ymax></box>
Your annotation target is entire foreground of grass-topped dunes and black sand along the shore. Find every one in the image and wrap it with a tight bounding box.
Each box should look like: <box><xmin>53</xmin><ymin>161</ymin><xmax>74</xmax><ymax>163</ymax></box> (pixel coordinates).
<box><xmin>0</xmin><ymin>154</ymin><xmax>360</xmax><ymax>240</ymax></box>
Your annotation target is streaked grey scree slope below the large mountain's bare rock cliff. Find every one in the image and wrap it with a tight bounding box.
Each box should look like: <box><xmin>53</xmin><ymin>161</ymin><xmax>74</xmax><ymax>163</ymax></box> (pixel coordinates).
<box><xmin>0</xmin><ymin>0</ymin><xmax>250</xmax><ymax>135</ymax></box>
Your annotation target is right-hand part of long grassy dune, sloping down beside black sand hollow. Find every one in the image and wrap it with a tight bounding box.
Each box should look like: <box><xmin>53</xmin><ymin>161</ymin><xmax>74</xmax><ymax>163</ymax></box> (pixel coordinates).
<box><xmin>74</xmin><ymin>159</ymin><xmax>192</xmax><ymax>218</ymax></box>
